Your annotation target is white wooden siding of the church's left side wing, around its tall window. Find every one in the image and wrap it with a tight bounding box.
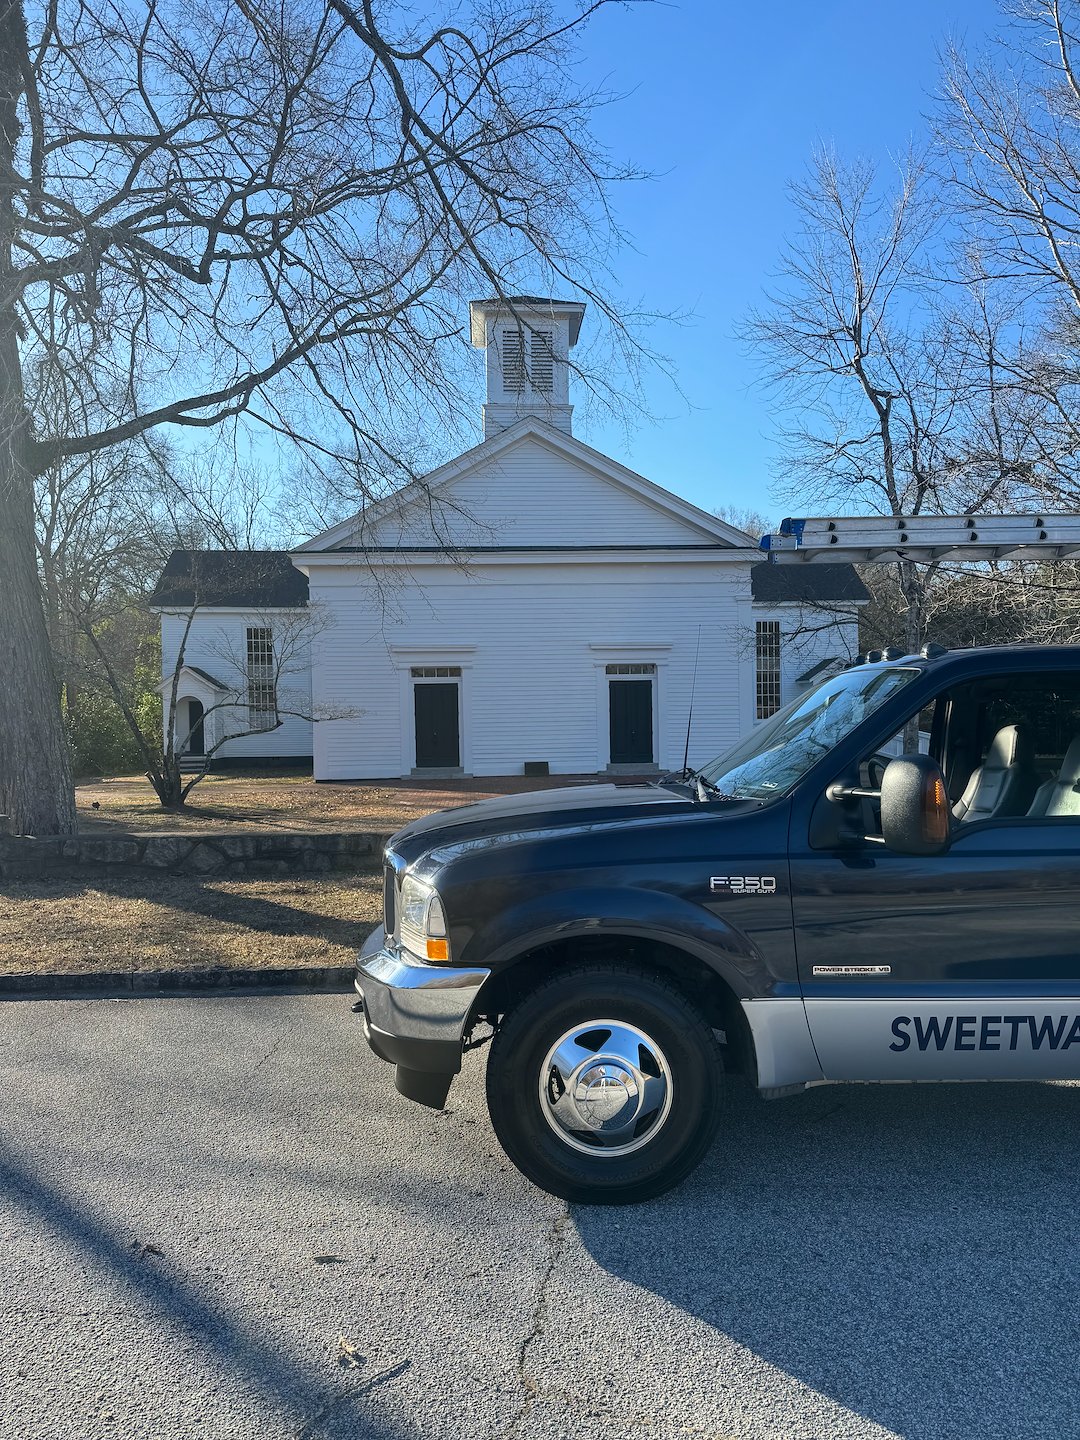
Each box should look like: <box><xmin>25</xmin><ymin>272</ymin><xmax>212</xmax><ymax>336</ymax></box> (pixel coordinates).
<box><xmin>161</xmin><ymin>608</ymin><xmax>312</xmax><ymax>759</ymax></box>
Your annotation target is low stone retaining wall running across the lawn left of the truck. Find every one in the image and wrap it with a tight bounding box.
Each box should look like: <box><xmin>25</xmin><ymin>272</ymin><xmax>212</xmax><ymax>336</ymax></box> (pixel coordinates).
<box><xmin>0</xmin><ymin>831</ymin><xmax>389</xmax><ymax>878</ymax></box>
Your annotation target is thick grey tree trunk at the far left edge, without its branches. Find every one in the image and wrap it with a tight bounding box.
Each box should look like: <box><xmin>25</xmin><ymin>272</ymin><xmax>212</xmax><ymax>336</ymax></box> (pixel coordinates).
<box><xmin>0</xmin><ymin>0</ymin><xmax>76</xmax><ymax>835</ymax></box>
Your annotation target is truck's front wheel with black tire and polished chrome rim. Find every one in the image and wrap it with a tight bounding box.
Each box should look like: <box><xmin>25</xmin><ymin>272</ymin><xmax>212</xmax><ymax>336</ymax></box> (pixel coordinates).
<box><xmin>487</xmin><ymin>965</ymin><xmax>724</xmax><ymax>1205</ymax></box>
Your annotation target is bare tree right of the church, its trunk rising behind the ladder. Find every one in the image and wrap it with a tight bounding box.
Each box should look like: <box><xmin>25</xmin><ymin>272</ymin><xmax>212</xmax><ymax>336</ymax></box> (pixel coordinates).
<box><xmin>746</xmin><ymin>151</ymin><xmax>936</xmax><ymax>645</ymax></box>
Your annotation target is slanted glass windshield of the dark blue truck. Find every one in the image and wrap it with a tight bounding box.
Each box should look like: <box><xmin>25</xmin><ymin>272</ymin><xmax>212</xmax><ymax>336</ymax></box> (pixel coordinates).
<box><xmin>700</xmin><ymin>667</ymin><xmax>919</xmax><ymax>799</ymax></box>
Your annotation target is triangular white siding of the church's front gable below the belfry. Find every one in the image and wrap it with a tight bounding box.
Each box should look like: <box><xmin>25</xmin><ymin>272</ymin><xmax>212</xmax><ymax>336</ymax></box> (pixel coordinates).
<box><xmin>347</xmin><ymin>436</ymin><xmax>714</xmax><ymax>547</ymax></box>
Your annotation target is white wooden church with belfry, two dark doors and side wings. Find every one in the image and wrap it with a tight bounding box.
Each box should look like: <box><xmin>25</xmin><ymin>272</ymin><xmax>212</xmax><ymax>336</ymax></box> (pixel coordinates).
<box><xmin>153</xmin><ymin>297</ymin><xmax>867</xmax><ymax>780</ymax></box>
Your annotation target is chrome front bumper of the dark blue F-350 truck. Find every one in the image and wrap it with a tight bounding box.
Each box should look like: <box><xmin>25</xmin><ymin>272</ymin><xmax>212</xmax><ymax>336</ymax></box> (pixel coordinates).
<box><xmin>356</xmin><ymin>927</ymin><xmax>491</xmax><ymax>1106</ymax></box>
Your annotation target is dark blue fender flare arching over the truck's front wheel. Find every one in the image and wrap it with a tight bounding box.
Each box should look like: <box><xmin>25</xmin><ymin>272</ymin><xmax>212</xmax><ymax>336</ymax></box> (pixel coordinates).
<box><xmin>461</xmin><ymin>887</ymin><xmax>773</xmax><ymax>999</ymax></box>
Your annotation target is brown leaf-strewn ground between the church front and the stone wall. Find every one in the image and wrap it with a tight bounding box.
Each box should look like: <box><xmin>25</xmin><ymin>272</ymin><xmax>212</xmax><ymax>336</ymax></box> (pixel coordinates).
<box><xmin>75</xmin><ymin>773</ymin><xmax>613</xmax><ymax>832</ymax></box>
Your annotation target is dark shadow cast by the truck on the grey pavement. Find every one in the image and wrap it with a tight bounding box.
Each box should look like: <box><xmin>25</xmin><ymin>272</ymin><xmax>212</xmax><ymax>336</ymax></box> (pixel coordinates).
<box><xmin>575</xmin><ymin>1084</ymin><xmax>1080</xmax><ymax>1440</ymax></box>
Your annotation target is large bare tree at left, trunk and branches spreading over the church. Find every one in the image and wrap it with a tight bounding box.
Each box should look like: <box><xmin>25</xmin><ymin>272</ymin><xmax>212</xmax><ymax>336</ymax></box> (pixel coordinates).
<box><xmin>0</xmin><ymin>0</ymin><xmax>648</xmax><ymax>831</ymax></box>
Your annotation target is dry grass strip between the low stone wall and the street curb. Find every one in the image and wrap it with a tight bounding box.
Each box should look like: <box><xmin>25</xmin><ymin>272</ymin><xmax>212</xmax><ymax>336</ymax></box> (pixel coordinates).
<box><xmin>0</xmin><ymin>871</ymin><xmax>382</xmax><ymax>975</ymax></box>
